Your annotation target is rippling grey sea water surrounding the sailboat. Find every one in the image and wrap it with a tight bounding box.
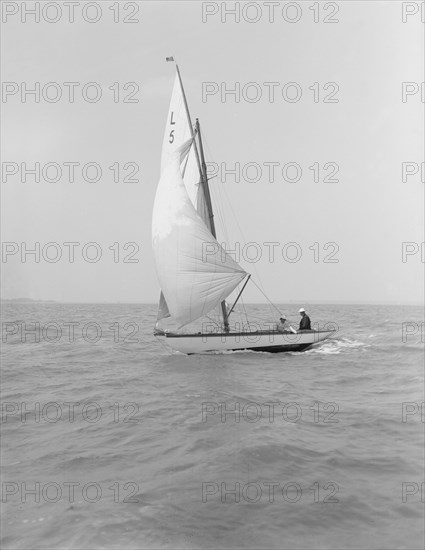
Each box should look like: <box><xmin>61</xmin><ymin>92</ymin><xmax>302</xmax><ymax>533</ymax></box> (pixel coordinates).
<box><xmin>1</xmin><ymin>303</ymin><xmax>425</xmax><ymax>549</ymax></box>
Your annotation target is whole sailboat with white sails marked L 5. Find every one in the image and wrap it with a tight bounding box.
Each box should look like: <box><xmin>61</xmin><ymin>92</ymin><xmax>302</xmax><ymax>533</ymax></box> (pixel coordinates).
<box><xmin>152</xmin><ymin>57</ymin><xmax>334</xmax><ymax>354</ymax></box>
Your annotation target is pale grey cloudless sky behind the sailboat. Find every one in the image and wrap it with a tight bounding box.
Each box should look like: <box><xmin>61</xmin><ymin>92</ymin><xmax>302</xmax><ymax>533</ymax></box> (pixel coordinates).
<box><xmin>1</xmin><ymin>1</ymin><xmax>425</xmax><ymax>304</ymax></box>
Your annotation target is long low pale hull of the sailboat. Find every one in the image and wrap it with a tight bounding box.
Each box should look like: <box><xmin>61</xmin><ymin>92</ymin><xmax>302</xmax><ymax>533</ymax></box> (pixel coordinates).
<box><xmin>164</xmin><ymin>330</ymin><xmax>335</xmax><ymax>355</ymax></box>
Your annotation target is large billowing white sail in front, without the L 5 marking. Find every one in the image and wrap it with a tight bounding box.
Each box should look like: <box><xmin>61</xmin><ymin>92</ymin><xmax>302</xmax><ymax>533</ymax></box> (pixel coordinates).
<box><xmin>152</xmin><ymin>140</ymin><xmax>246</xmax><ymax>325</ymax></box>
